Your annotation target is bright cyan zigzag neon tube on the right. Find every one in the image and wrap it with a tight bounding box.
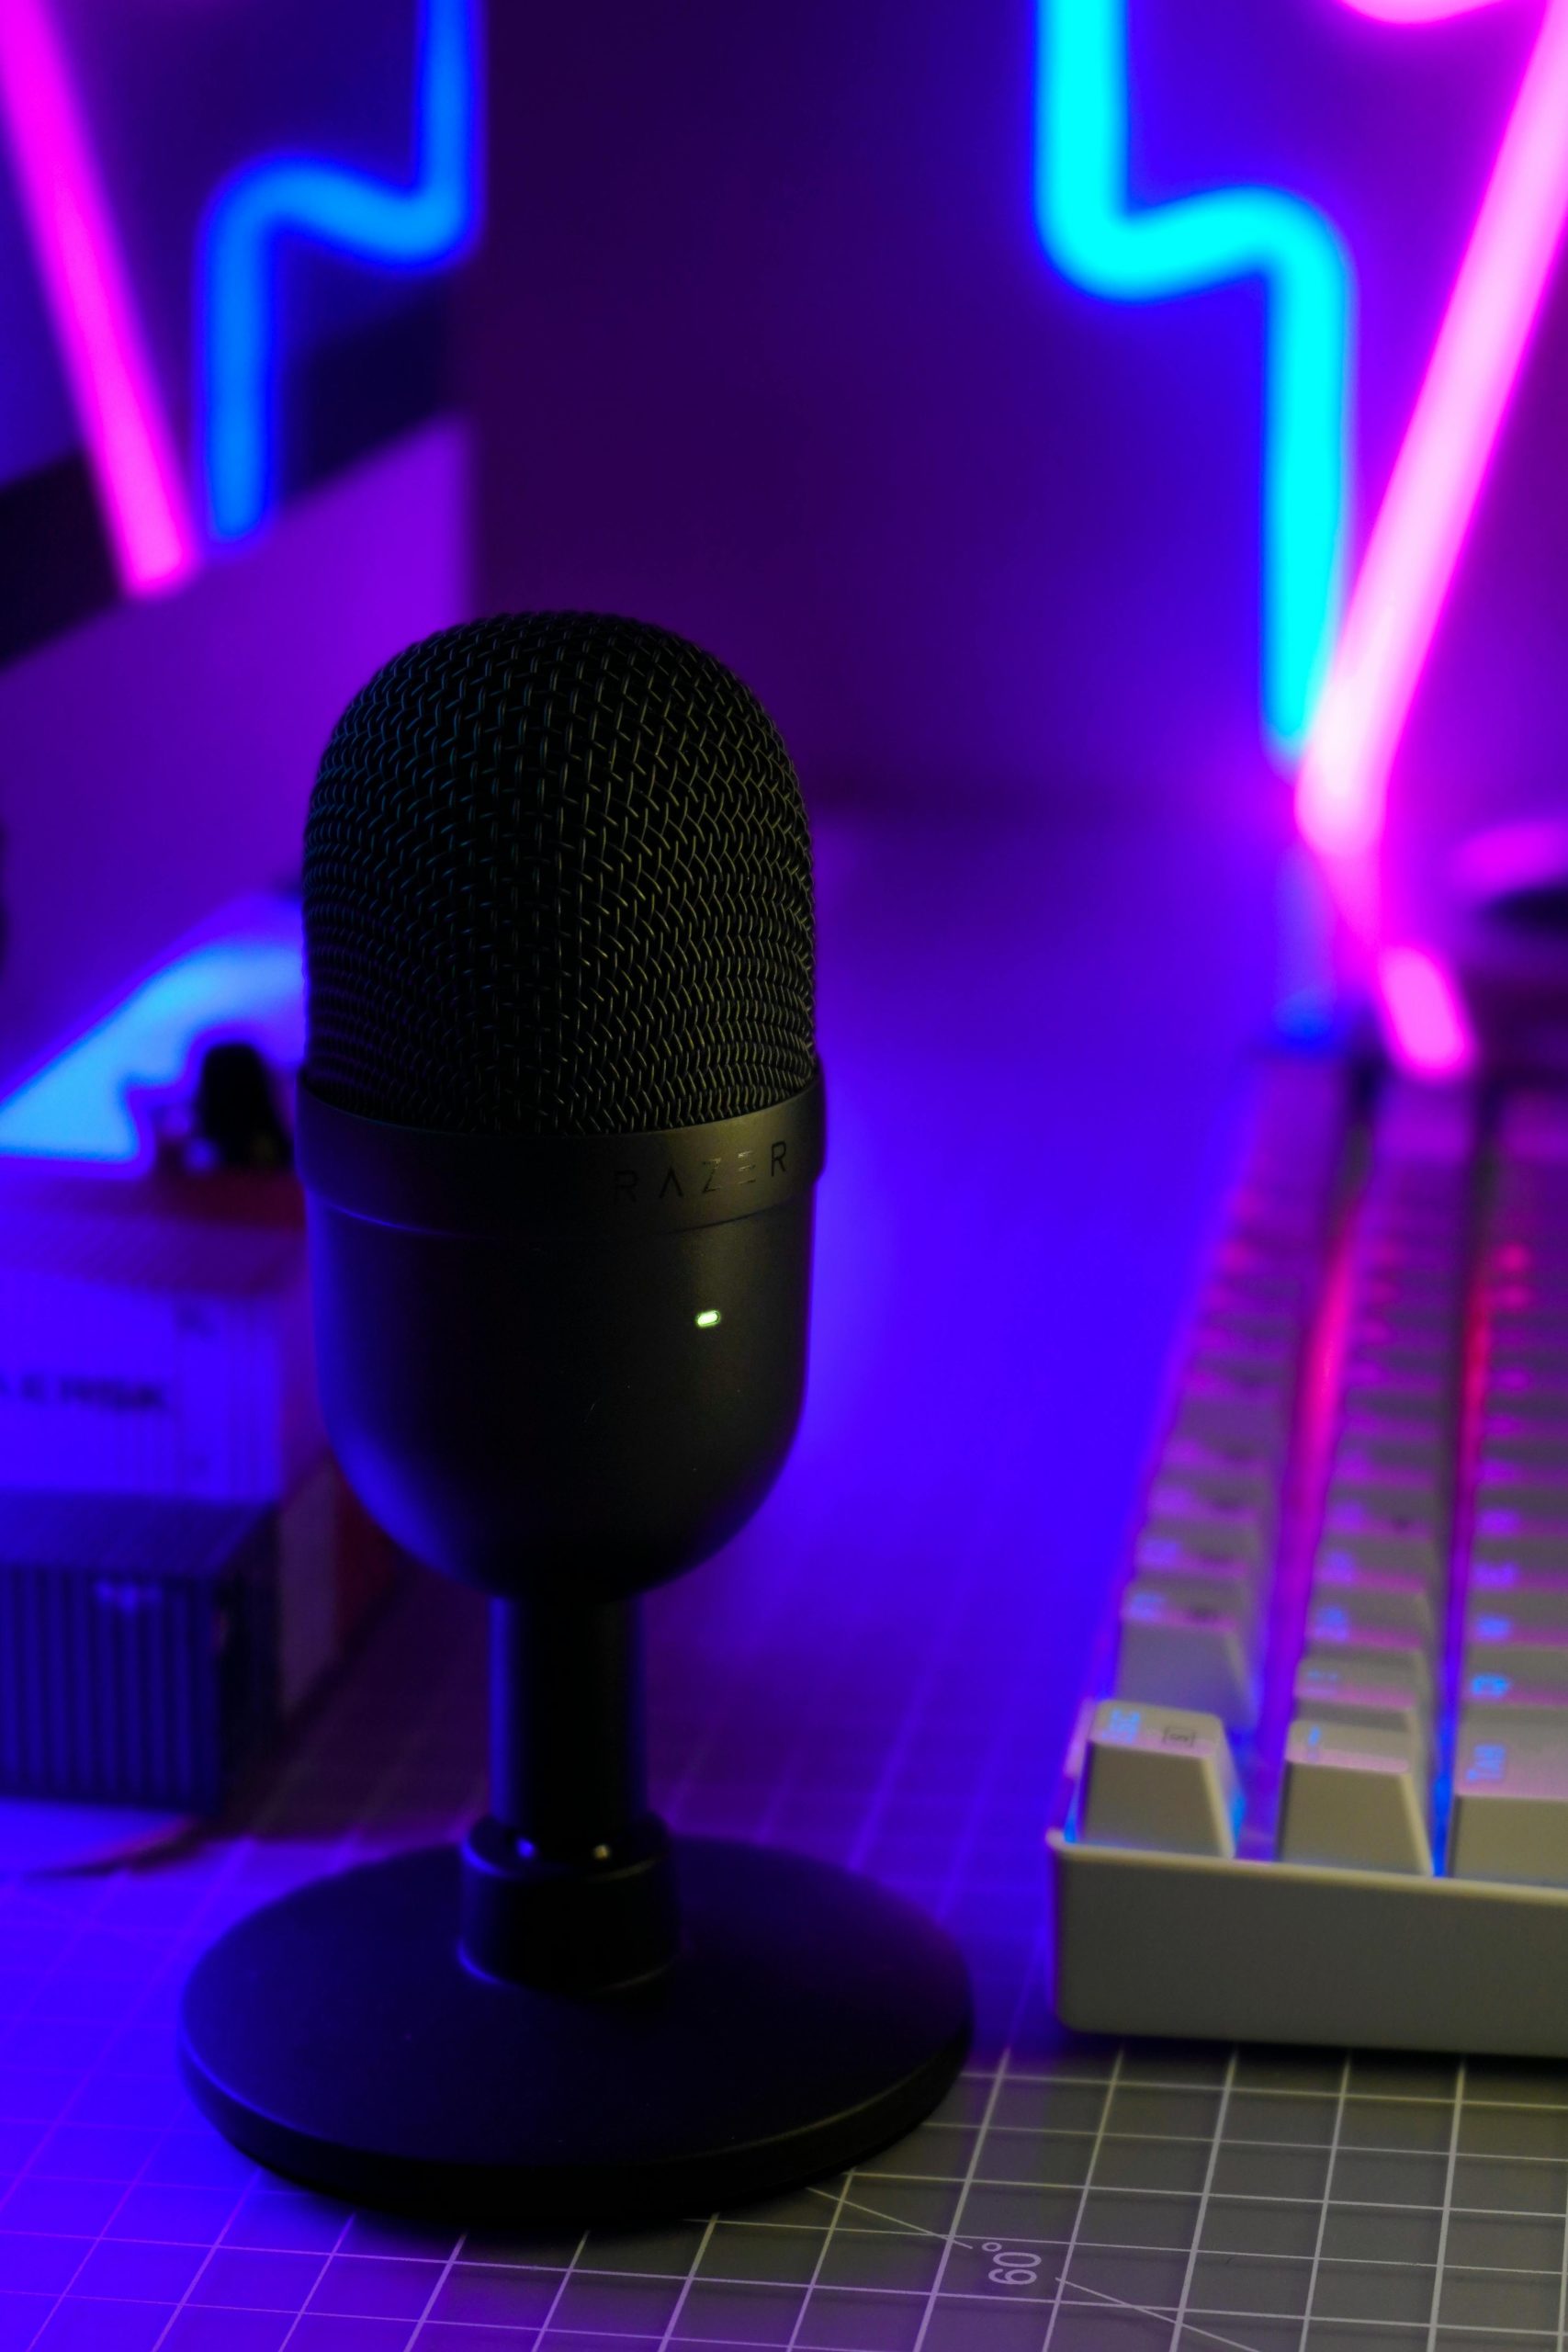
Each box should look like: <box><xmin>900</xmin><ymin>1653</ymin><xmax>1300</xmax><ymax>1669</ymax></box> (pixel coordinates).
<box><xmin>1034</xmin><ymin>0</ymin><xmax>1354</xmax><ymax>752</ymax></box>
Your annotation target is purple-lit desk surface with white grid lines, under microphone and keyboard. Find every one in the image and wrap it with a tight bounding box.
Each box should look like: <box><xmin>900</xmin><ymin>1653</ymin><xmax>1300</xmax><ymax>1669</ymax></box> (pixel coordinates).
<box><xmin>0</xmin><ymin>828</ymin><xmax>1568</xmax><ymax>2352</ymax></box>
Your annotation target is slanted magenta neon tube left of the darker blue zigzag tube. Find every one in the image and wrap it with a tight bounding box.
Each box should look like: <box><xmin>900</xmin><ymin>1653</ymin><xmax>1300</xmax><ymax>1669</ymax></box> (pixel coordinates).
<box><xmin>0</xmin><ymin>0</ymin><xmax>200</xmax><ymax>595</ymax></box>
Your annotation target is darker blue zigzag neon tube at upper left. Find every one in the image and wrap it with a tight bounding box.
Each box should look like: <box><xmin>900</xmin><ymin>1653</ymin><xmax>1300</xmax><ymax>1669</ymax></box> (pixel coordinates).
<box><xmin>200</xmin><ymin>0</ymin><xmax>479</xmax><ymax>538</ymax></box>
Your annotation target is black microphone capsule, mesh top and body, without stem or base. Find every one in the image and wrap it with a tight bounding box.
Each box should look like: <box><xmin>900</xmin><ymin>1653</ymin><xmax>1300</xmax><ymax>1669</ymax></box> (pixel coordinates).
<box><xmin>299</xmin><ymin>614</ymin><xmax>823</xmax><ymax>1600</ymax></box>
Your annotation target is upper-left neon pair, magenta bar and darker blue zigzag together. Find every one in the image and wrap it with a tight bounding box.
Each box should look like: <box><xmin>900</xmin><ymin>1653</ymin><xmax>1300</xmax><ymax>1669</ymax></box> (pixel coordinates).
<box><xmin>0</xmin><ymin>0</ymin><xmax>479</xmax><ymax>595</ymax></box>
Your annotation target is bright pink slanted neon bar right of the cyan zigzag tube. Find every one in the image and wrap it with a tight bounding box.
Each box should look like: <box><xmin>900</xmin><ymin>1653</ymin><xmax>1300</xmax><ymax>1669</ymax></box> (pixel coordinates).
<box><xmin>1295</xmin><ymin>0</ymin><xmax>1568</xmax><ymax>856</ymax></box>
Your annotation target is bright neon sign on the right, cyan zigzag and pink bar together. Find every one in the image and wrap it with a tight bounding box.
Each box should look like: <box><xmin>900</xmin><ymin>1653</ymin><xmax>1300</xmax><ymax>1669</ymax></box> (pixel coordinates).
<box><xmin>1034</xmin><ymin>0</ymin><xmax>1568</xmax><ymax>856</ymax></box>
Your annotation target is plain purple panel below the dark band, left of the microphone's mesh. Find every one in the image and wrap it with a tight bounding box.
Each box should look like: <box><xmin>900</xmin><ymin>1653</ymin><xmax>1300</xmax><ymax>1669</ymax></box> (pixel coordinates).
<box><xmin>0</xmin><ymin>424</ymin><xmax>468</xmax><ymax>1075</ymax></box>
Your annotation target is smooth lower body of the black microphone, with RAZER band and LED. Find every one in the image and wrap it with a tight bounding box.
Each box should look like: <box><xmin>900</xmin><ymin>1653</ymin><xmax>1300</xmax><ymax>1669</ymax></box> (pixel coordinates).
<box><xmin>299</xmin><ymin>1080</ymin><xmax>823</xmax><ymax>1601</ymax></box>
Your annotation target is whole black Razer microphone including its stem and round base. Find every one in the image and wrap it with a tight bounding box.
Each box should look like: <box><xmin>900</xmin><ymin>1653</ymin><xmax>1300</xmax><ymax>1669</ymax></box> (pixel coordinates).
<box><xmin>181</xmin><ymin>614</ymin><xmax>968</xmax><ymax>2221</ymax></box>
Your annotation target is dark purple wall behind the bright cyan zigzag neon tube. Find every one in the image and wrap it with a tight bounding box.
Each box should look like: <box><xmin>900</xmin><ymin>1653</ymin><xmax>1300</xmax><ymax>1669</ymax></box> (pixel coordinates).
<box><xmin>470</xmin><ymin>0</ymin><xmax>1568</xmax><ymax>865</ymax></box>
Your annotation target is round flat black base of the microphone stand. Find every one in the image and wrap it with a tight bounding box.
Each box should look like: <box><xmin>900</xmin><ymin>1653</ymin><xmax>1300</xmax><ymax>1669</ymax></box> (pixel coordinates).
<box><xmin>179</xmin><ymin>1839</ymin><xmax>971</xmax><ymax>2230</ymax></box>
